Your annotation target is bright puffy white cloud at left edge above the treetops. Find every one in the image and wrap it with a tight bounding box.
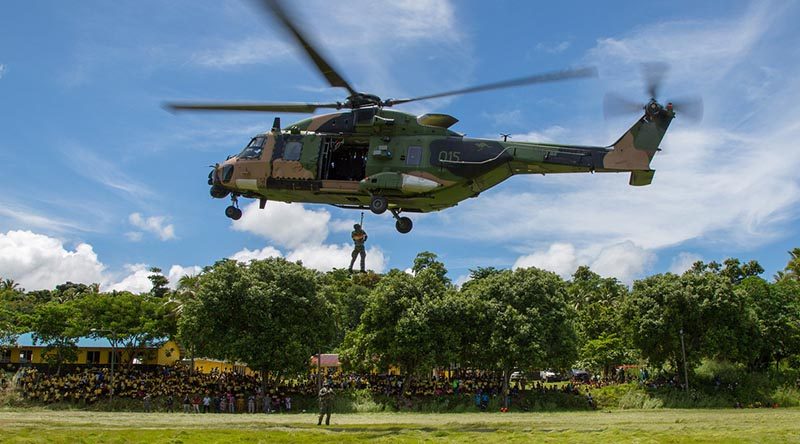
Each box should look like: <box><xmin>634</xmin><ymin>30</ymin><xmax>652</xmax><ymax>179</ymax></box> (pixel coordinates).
<box><xmin>0</xmin><ymin>231</ymin><xmax>105</xmax><ymax>290</ymax></box>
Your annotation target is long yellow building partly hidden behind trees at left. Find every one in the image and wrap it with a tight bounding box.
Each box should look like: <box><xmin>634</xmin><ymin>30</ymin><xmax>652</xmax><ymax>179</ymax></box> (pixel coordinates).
<box><xmin>0</xmin><ymin>333</ymin><xmax>180</xmax><ymax>365</ymax></box>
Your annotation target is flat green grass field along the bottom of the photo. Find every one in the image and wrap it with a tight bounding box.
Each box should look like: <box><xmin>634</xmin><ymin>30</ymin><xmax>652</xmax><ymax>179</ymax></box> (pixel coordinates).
<box><xmin>0</xmin><ymin>409</ymin><xmax>800</xmax><ymax>443</ymax></box>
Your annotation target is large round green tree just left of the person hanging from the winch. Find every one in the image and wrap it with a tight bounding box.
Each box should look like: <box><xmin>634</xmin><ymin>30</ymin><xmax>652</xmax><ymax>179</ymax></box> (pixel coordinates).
<box><xmin>180</xmin><ymin>258</ymin><xmax>333</xmax><ymax>390</ymax></box>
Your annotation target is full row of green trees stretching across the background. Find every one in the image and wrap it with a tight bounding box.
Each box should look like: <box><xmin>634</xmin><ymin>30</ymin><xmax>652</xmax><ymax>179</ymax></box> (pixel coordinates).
<box><xmin>0</xmin><ymin>248</ymin><xmax>800</xmax><ymax>402</ymax></box>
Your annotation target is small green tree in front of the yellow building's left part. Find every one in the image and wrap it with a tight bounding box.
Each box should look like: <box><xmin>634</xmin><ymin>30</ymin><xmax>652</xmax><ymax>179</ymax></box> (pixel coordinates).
<box><xmin>30</xmin><ymin>302</ymin><xmax>81</xmax><ymax>374</ymax></box>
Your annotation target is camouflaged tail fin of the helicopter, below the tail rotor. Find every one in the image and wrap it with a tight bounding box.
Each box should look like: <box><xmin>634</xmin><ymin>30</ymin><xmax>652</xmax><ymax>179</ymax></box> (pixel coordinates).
<box><xmin>603</xmin><ymin>110</ymin><xmax>674</xmax><ymax>186</ymax></box>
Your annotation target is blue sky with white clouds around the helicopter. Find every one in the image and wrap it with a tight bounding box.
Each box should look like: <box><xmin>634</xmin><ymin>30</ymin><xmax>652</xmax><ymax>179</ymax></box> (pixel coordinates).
<box><xmin>0</xmin><ymin>0</ymin><xmax>800</xmax><ymax>292</ymax></box>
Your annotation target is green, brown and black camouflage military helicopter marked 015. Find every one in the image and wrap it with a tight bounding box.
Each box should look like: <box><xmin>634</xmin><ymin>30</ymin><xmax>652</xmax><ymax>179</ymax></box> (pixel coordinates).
<box><xmin>166</xmin><ymin>0</ymin><xmax>700</xmax><ymax>233</ymax></box>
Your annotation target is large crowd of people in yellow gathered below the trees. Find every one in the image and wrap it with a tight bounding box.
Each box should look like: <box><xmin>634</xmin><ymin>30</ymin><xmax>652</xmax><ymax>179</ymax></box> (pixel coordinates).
<box><xmin>14</xmin><ymin>366</ymin><xmax>600</xmax><ymax>413</ymax></box>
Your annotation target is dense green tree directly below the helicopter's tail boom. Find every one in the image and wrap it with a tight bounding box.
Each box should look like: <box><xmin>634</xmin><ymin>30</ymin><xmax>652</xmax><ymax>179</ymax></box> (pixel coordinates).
<box><xmin>464</xmin><ymin>268</ymin><xmax>577</xmax><ymax>408</ymax></box>
